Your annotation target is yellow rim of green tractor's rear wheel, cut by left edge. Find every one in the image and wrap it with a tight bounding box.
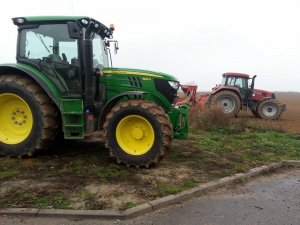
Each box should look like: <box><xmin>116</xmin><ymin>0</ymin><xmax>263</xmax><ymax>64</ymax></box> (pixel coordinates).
<box><xmin>0</xmin><ymin>93</ymin><xmax>33</xmax><ymax>145</ymax></box>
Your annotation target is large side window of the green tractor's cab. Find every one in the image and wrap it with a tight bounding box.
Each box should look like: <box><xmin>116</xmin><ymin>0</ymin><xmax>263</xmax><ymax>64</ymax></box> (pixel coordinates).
<box><xmin>18</xmin><ymin>24</ymin><xmax>81</xmax><ymax>95</ymax></box>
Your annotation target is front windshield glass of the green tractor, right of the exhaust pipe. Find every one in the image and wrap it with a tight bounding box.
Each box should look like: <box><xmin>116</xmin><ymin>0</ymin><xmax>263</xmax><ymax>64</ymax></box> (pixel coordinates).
<box><xmin>93</xmin><ymin>34</ymin><xmax>108</xmax><ymax>69</ymax></box>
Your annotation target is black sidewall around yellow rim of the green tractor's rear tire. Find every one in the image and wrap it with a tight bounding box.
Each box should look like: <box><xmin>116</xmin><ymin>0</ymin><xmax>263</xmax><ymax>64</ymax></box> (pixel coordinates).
<box><xmin>0</xmin><ymin>82</ymin><xmax>43</xmax><ymax>156</ymax></box>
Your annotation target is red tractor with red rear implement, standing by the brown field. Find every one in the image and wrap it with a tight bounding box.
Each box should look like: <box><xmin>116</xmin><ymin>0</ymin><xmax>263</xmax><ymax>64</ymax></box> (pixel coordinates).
<box><xmin>178</xmin><ymin>73</ymin><xmax>286</xmax><ymax>120</ymax></box>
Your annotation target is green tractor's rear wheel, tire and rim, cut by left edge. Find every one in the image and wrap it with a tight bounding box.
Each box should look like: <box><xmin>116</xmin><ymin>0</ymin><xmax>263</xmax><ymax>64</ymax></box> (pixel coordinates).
<box><xmin>0</xmin><ymin>75</ymin><xmax>59</xmax><ymax>157</ymax></box>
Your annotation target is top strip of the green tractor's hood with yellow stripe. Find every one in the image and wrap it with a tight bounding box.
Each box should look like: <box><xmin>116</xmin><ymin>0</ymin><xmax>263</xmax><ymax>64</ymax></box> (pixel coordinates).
<box><xmin>103</xmin><ymin>68</ymin><xmax>178</xmax><ymax>81</ymax></box>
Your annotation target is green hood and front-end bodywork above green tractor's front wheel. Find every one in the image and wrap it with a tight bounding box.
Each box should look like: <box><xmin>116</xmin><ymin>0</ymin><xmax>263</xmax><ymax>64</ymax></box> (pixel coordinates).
<box><xmin>100</xmin><ymin>68</ymin><xmax>189</xmax><ymax>139</ymax></box>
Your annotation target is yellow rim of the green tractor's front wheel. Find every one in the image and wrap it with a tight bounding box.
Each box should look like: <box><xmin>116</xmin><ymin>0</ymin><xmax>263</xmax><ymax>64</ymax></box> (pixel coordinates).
<box><xmin>116</xmin><ymin>115</ymin><xmax>155</xmax><ymax>155</ymax></box>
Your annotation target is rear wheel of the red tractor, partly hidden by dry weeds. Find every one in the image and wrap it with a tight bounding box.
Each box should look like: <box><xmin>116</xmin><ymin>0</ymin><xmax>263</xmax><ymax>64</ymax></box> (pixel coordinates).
<box><xmin>210</xmin><ymin>90</ymin><xmax>241</xmax><ymax>117</ymax></box>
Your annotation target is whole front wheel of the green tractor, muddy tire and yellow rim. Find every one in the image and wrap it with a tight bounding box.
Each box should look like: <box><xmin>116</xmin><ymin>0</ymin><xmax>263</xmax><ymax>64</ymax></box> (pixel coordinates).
<box><xmin>103</xmin><ymin>100</ymin><xmax>173</xmax><ymax>168</ymax></box>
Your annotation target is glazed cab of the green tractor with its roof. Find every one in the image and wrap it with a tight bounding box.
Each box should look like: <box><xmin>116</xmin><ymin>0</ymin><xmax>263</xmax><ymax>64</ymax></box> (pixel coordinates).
<box><xmin>13</xmin><ymin>17</ymin><xmax>113</xmax><ymax>97</ymax></box>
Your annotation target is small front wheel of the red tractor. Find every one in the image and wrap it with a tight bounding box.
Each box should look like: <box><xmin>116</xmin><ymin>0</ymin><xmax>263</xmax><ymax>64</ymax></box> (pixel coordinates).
<box><xmin>257</xmin><ymin>99</ymin><xmax>282</xmax><ymax>120</ymax></box>
